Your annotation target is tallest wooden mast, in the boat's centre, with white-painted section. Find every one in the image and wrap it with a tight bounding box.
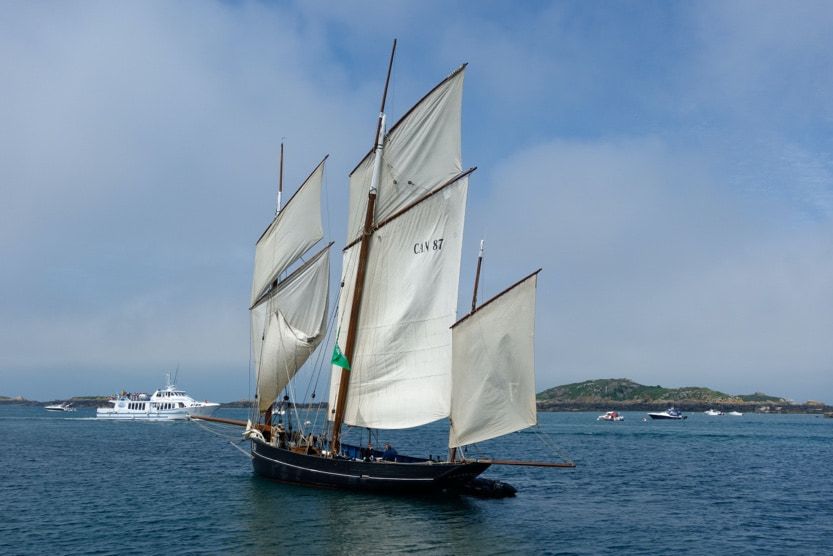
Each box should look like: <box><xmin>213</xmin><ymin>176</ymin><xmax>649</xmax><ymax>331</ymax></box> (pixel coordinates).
<box><xmin>330</xmin><ymin>39</ymin><xmax>396</xmax><ymax>454</ymax></box>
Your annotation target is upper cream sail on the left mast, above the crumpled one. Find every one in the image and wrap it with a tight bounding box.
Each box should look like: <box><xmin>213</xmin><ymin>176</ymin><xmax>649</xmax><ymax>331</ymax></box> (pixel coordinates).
<box><xmin>250</xmin><ymin>159</ymin><xmax>326</xmax><ymax>305</ymax></box>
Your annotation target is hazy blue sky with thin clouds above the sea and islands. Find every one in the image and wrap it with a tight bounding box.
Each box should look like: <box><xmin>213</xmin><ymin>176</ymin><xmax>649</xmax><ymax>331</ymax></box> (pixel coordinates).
<box><xmin>0</xmin><ymin>1</ymin><xmax>833</xmax><ymax>403</ymax></box>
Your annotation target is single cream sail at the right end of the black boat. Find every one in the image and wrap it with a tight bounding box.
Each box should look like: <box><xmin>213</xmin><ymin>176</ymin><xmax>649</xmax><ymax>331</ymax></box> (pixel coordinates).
<box><xmin>448</xmin><ymin>272</ymin><xmax>538</xmax><ymax>448</ymax></box>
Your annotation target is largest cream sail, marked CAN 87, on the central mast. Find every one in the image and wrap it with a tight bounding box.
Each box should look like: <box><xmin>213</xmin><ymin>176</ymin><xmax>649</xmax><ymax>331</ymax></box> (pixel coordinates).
<box><xmin>330</xmin><ymin>175</ymin><xmax>468</xmax><ymax>429</ymax></box>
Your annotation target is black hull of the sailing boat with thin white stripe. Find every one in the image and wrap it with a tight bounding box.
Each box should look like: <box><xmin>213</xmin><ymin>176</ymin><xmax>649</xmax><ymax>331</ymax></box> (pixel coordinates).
<box><xmin>252</xmin><ymin>440</ymin><xmax>490</xmax><ymax>494</ymax></box>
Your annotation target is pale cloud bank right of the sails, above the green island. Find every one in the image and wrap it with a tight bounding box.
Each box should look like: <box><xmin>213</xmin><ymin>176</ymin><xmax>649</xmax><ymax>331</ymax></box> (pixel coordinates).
<box><xmin>474</xmin><ymin>139</ymin><xmax>833</xmax><ymax>398</ymax></box>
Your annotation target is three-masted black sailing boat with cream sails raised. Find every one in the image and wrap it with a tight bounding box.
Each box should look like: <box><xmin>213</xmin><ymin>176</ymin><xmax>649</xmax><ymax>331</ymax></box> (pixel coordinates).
<box><xmin>202</xmin><ymin>41</ymin><xmax>574</xmax><ymax>496</ymax></box>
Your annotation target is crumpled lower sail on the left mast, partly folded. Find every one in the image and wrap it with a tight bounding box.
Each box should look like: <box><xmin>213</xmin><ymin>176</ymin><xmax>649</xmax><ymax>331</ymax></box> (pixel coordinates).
<box><xmin>251</xmin><ymin>246</ymin><xmax>330</xmax><ymax>411</ymax></box>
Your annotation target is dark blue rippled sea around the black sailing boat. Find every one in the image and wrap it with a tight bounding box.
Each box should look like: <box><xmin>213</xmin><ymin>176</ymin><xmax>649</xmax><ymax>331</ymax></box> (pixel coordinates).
<box><xmin>0</xmin><ymin>406</ymin><xmax>833</xmax><ymax>556</ymax></box>
